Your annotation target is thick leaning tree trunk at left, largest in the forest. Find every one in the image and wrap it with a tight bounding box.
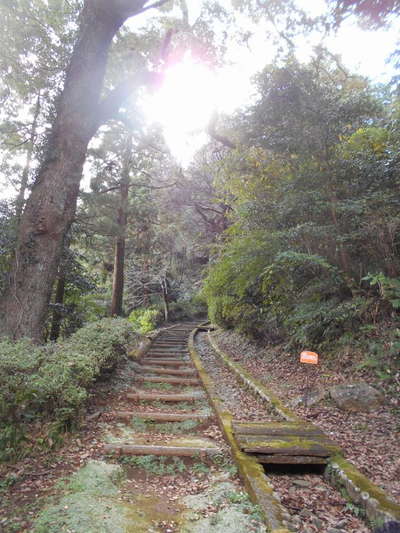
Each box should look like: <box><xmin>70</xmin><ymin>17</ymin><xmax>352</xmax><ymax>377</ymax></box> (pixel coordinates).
<box><xmin>0</xmin><ymin>0</ymin><xmax>162</xmax><ymax>342</ymax></box>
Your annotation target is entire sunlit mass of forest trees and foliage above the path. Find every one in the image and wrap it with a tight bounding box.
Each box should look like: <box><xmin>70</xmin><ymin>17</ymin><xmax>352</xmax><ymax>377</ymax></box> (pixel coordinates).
<box><xmin>0</xmin><ymin>0</ymin><xmax>400</xmax><ymax>362</ymax></box>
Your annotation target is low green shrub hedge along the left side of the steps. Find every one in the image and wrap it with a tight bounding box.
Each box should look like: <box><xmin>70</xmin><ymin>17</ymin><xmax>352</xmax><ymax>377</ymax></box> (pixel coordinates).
<box><xmin>0</xmin><ymin>318</ymin><xmax>135</xmax><ymax>459</ymax></box>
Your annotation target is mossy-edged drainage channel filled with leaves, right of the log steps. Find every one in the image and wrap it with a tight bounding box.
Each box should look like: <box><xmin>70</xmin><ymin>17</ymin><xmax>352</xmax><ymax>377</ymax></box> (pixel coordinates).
<box><xmin>190</xmin><ymin>326</ymin><xmax>400</xmax><ymax>533</ymax></box>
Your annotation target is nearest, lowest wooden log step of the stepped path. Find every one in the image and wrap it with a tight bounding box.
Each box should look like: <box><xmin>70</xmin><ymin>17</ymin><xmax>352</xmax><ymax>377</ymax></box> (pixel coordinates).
<box><xmin>103</xmin><ymin>444</ymin><xmax>221</xmax><ymax>457</ymax></box>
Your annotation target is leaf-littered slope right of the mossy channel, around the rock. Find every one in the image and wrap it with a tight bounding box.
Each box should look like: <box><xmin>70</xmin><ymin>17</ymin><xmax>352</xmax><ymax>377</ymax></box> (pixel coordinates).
<box><xmin>215</xmin><ymin>326</ymin><xmax>400</xmax><ymax>502</ymax></box>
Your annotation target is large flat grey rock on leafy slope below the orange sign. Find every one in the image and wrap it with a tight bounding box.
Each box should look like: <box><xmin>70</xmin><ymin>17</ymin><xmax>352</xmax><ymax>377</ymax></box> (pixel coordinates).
<box><xmin>329</xmin><ymin>383</ymin><xmax>383</xmax><ymax>411</ymax></box>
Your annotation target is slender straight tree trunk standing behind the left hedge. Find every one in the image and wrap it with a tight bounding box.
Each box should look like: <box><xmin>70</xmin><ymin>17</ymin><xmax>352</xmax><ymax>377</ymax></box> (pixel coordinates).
<box><xmin>111</xmin><ymin>140</ymin><xmax>132</xmax><ymax>316</ymax></box>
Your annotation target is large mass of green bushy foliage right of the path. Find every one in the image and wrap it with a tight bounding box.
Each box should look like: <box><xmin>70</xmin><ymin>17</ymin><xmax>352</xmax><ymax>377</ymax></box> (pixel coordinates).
<box><xmin>203</xmin><ymin>49</ymin><xmax>400</xmax><ymax>360</ymax></box>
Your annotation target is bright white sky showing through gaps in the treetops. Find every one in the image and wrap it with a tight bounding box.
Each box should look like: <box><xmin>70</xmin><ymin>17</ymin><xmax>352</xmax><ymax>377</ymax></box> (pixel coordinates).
<box><xmin>145</xmin><ymin>0</ymin><xmax>400</xmax><ymax>166</ymax></box>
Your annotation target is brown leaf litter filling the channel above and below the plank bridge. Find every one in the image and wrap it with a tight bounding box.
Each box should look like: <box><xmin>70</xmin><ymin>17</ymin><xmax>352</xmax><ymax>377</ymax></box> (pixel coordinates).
<box><xmin>196</xmin><ymin>333</ymin><xmax>370</xmax><ymax>533</ymax></box>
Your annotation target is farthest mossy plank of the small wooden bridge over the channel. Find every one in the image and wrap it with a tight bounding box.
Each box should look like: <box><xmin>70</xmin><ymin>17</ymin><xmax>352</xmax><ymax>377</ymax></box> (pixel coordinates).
<box><xmin>232</xmin><ymin>422</ymin><xmax>324</xmax><ymax>436</ymax></box>
